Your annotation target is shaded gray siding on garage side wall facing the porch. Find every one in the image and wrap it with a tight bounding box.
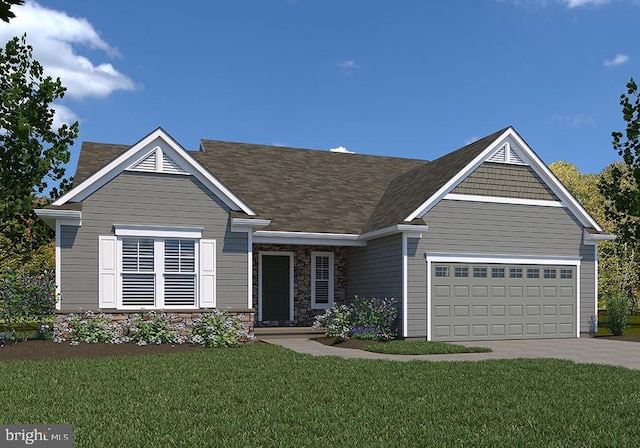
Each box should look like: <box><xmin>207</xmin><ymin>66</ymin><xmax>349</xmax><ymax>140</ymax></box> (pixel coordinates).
<box><xmin>347</xmin><ymin>234</ymin><xmax>402</xmax><ymax>326</ymax></box>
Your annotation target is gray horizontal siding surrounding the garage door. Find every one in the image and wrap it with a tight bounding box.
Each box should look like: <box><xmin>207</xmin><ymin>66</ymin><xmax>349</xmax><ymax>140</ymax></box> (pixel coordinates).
<box><xmin>407</xmin><ymin>199</ymin><xmax>595</xmax><ymax>337</ymax></box>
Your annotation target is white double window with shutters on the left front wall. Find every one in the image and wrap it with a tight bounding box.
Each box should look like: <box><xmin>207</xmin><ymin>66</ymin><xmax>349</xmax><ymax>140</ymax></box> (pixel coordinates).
<box><xmin>99</xmin><ymin>225</ymin><xmax>216</xmax><ymax>309</ymax></box>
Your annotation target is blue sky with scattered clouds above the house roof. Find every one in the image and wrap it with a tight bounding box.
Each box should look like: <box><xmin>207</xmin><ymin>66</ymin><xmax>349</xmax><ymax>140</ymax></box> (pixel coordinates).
<box><xmin>0</xmin><ymin>0</ymin><xmax>640</xmax><ymax>172</ymax></box>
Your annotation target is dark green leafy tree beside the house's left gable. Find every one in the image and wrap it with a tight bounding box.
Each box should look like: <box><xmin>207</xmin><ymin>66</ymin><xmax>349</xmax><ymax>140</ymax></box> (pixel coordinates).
<box><xmin>0</xmin><ymin>34</ymin><xmax>78</xmax><ymax>250</ymax></box>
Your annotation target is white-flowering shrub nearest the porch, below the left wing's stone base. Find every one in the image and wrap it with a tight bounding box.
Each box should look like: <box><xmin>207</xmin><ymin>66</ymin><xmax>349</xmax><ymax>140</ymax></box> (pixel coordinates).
<box><xmin>190</xmin><ymin>310</ymin><xmax>254</xmax><ymax>347</ymax></box>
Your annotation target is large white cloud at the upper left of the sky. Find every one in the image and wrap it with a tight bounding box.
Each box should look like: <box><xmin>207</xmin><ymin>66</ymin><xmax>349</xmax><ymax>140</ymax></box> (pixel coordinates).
<box><xmin>0</xmin><ymin>0</ymin><xmax>136</xmax><ymax>99</ymax></box>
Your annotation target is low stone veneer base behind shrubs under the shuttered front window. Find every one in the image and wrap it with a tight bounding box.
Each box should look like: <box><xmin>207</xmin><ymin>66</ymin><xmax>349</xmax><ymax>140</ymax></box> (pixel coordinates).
<box><xmin>53</xmin><ymin>309</ymin><xmax>255</xmax><ymax>339</ymax></box>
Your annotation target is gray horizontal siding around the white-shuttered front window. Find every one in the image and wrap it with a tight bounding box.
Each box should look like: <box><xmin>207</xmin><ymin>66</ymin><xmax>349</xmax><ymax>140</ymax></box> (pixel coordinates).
<box><xmin>61</xmin><ymin>171</ymin><xmax>248</xmax><ymax>311</ymax></box>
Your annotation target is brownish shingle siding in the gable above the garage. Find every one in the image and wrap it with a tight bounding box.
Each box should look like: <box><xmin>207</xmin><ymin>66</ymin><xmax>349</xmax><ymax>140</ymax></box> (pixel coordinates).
<box><xmin>452</xmin><ymin>162</ymin><xmax>558</xmax><ymax>201</ymax></box>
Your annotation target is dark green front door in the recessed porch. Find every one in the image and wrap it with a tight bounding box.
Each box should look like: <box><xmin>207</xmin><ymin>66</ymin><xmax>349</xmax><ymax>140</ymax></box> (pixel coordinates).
<box><xmin>262</xmin><ymin>255</ymin><xmax>291</xmax><ymax>321</ymax></box>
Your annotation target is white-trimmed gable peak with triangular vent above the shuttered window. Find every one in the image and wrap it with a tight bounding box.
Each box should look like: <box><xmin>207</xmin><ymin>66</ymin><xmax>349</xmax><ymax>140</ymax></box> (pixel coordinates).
<box><xmin>52</xmin><ymin>128</ymin><xmax>255</xmax><ymax>216</ymax></box>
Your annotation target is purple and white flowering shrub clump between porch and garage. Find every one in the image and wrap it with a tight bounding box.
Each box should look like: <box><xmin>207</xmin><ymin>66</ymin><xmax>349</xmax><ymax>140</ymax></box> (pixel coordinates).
<box><xmin>313</xmin><ymin>296</ymin><xmax>398</xmax><ymax>341</ymax></box>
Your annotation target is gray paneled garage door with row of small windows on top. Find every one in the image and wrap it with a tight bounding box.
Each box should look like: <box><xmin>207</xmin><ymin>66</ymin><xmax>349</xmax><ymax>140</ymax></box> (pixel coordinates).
<box><xmin>431</xmin><ymin>262</ymin><xmax>577</xmax><ymax>341</ymax></box>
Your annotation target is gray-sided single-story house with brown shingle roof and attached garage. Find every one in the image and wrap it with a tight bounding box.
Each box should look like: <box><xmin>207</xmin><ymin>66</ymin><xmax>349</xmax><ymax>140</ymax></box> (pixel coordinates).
<box><xmin>37</xmin><ymin>127</ymin><xmax>613</xmax><ymax>341</ymax></box>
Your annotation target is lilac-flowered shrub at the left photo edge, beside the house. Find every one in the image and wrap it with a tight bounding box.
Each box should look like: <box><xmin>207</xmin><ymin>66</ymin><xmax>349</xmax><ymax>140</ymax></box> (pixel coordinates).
<box><xmin>0</xmin><ymin>269</ymin><xmax>57</xmax><ymax>324</ymax></box>
